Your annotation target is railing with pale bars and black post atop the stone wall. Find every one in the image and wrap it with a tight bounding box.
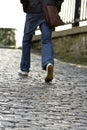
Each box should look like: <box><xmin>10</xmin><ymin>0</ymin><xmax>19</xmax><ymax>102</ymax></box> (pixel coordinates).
<box><xmin>60</xmin><ymin>0</ymin><xmax>87</xmax><ymax>26</ymax></box>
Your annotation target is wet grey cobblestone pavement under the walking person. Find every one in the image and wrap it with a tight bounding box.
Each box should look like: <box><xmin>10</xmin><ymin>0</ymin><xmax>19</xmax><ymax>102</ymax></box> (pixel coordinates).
<box><xmin>0</xmin><ymin>49</ymin><xmax>87</xmax><ymax>130</ymax></box>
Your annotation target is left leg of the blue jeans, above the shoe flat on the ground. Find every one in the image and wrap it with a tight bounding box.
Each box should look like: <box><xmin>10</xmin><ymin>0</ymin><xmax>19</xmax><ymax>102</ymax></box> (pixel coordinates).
<box><xmin>20</xmin><ymin>14</ymin><xmax>37</xmax><ymax>73</ymax></box>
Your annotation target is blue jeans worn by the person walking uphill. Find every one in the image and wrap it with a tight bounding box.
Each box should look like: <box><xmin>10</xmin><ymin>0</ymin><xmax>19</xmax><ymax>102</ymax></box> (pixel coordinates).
<box><xmin>20</xmin><ymin>13</ymin><xmax>54</xmax><ymax>72</ymax></box>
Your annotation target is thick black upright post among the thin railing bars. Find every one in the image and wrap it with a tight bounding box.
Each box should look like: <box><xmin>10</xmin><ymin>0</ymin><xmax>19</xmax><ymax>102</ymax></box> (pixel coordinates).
<box><xmin>72</xmin><ymin>0</ymin><xmax>81</xmax><ymax>27</ymax></box>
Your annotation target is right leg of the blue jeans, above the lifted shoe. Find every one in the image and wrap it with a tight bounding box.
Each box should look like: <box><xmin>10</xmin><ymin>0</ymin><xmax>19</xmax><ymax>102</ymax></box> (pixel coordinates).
<box><xmin>40</xmin><ymin>22</ymin><xmax>54</xmax><ymax>69</ymax></box>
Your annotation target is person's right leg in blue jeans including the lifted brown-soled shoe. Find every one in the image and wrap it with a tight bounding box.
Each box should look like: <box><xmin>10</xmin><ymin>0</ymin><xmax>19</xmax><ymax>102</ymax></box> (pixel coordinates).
<box><xmin>40</xmin><ymin>22</ymin><xmax>54</xmax><ymax>82</ymax></box>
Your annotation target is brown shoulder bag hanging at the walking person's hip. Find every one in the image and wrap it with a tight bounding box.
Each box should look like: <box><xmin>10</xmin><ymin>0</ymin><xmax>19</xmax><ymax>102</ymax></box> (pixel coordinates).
<box><xmin>40</xmin><ymin>0</ymin><xmax>64</xmax><ymax>27</ymax></box>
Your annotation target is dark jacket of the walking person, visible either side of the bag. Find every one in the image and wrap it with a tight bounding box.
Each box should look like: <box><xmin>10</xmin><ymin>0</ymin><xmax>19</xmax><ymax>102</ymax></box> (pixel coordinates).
<box><xmin>20</xmin><ymin>0</ymin><xmax>64</xmax><ymax>13</ymax></box>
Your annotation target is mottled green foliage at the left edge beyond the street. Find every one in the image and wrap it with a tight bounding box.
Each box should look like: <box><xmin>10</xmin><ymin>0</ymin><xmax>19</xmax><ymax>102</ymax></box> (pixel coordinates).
<box><xmin>0</xmin><ymin>28</ymin><xmax>16</xmax><ymax>46</ymax></box>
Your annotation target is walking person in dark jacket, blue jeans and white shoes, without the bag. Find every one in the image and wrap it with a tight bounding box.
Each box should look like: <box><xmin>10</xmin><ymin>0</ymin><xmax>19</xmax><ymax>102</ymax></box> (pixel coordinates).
<box><xmin>19</xmin><ymin>0</ymin><xmax>63</xmax><ymax>82</ymax></box>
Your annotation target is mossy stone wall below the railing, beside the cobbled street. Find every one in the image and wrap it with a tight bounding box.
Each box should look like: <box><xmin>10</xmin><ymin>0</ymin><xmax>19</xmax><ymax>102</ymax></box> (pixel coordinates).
<box><xmin>32</xmin><ymin>27</ymin><xmax>87</xmax><ymax>65</ymax></box>
